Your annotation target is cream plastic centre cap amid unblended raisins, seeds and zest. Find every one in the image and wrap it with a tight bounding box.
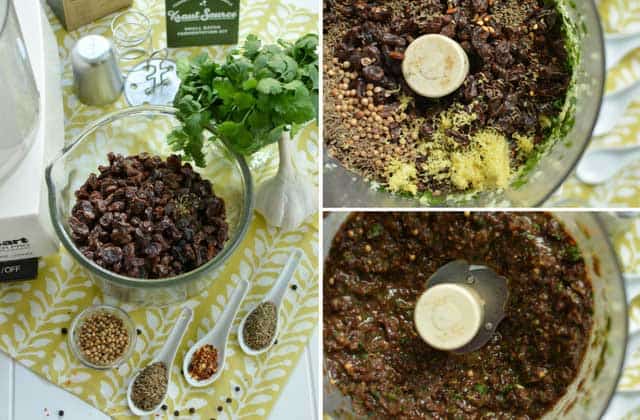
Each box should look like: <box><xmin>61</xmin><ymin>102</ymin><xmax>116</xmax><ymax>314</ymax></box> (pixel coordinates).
<box><xmin>402</xmin><ymin>34</ymin><xmax>469</xmax><ymax>98</ymax></box>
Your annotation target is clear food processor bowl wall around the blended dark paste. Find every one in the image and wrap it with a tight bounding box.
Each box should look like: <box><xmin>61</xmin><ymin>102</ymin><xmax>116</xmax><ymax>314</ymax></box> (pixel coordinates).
<box><xmin>323</xmin><ymin>212</ymin><xmax>628</xmax><ymax>420</ymax></box>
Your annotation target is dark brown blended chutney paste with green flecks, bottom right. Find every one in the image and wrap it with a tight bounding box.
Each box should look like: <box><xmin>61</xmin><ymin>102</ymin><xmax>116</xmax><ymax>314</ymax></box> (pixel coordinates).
<box><xmin>323</xmin><ymin>213</ymin><xmax>593</xmax><ymax>419</ymax></box>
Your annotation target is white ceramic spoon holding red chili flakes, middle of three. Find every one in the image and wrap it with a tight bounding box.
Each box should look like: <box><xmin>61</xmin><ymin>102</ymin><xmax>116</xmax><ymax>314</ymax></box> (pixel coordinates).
<box><xmin>182</xmin><ymin>280</ymin><xmax>249</xmax><ymax>387</ymax></box>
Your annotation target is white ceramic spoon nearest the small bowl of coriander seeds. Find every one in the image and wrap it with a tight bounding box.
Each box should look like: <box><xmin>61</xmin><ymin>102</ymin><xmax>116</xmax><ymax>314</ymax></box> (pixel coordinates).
<box><xmin>127</xmin><ymin>307</ymin><xmax>193</xmax><ymax>417</ymax></box>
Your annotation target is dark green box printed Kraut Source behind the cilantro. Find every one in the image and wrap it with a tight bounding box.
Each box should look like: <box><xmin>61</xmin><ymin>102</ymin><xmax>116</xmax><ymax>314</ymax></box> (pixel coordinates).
<box><xmin>165</xmin><ymin>0</ymin><xmax>240</xmax><ymax>47</ymax></box>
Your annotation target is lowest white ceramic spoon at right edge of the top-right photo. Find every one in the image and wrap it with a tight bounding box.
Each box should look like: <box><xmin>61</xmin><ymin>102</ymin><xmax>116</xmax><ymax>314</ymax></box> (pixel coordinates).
<box><xmin>576</xmin><ymin>146</ymin><xmax>640</xmax><ymax>185</ymax></box>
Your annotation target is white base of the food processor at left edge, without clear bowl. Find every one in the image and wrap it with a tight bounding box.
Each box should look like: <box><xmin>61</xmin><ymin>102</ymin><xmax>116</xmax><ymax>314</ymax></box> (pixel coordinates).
<box><xmin>0</xmin><ymin>2</ymin><xmax>64</xmax><ymax>266</ymax></box>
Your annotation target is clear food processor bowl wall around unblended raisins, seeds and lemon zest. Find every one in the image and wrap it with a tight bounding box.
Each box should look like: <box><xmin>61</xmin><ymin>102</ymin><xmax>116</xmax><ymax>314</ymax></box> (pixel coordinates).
<box><xmin>323</xmin><ymin>0</ymin><xmax>606</xmax><ymax>208</ymax></box>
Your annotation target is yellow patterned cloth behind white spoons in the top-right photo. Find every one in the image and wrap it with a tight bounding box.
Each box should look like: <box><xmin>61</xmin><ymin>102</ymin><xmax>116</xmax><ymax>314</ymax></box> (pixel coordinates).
<box><xmin>551</xmin><ymin>0</ymin><xmax>640</xmax><ymax>207</ymax></box>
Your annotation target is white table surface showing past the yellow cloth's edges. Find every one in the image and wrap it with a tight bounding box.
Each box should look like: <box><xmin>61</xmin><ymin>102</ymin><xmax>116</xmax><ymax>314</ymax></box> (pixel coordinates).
<box><xmin>0</xmin><ymin>0</ymin><xmax>320</xmax><ymax>420</ymax></box>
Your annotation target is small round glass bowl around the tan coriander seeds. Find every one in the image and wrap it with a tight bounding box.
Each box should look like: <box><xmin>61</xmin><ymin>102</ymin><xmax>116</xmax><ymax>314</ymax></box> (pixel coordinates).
<box><xmin>69</xmin><ymin>305</ymin><xmax>137</xmax><ymax>370</ymax></box>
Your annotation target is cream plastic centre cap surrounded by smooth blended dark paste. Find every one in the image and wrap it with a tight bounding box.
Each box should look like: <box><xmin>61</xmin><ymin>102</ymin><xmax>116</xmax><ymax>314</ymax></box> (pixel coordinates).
<box><xmin>414</xmin><ymin>283</ymin><xmax>484</xmax><ymax>351</ymax></box>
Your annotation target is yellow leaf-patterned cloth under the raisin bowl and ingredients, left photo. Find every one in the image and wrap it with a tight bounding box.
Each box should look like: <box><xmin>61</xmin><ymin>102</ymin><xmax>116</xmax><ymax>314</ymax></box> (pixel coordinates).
<box><xmin>0</xmin><ymin>0</ymin><xmax>319</xmax><ymax>419</ymax></box>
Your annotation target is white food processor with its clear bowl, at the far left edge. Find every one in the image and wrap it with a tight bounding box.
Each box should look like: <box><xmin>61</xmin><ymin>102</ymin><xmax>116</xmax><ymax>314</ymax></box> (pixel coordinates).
<box><xmin>0</xmin><ymin>0</ymin><xmax>64</xmax><ymax>281</ymax></box>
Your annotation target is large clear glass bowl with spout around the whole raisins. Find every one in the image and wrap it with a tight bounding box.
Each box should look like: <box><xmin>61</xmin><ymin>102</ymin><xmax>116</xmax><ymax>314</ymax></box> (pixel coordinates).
<box><xmin>46</xmin><ymin>106</ymin><xmax>253</xmax><ymax>305</ymax></box>
